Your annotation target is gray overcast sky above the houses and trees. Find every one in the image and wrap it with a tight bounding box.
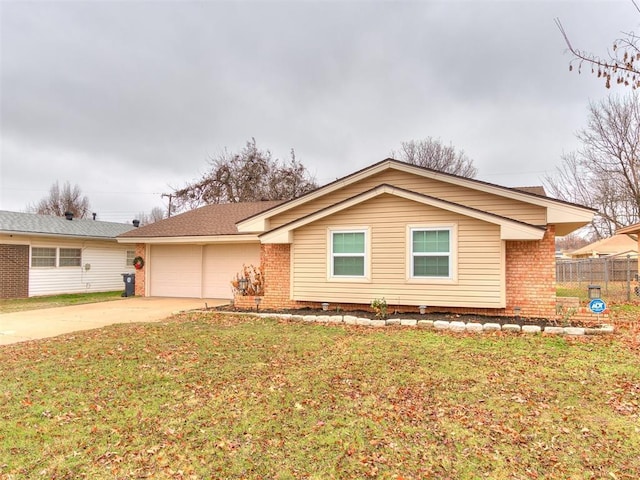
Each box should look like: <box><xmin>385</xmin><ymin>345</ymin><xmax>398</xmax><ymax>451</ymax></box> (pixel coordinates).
<box><xmin>0</xmin><ymin>0</ymin><xmax>640</xmax><ymax>222</ymax></box>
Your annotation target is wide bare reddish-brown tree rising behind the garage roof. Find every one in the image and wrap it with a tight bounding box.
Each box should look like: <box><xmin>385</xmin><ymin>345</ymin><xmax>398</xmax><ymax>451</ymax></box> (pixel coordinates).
<box><xmin>171</xmin><ymin>138</ymin><xmax>317</xmax><ymax>211</ymax></box>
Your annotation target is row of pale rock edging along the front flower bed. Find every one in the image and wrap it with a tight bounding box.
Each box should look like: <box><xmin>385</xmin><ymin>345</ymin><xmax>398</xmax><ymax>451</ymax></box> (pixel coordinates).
<box><xmin>221</xmin><ymin>312</ymin><xmax>614</xmax><ymax>336</ymax></box>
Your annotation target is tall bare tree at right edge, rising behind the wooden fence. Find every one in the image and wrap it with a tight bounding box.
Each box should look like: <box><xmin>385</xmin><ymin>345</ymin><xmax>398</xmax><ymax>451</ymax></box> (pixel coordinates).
<box><xmin>545</xmin><ymin>92</ymin><xmax>640</xmax><ymax>238</ymax></box>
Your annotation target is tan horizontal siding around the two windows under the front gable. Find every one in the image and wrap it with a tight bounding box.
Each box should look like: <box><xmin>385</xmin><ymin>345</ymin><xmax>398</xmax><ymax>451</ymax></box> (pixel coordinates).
<box><xmin>292</xmin><ymin>195</ymin><xmax>504</xmax><ymax>307</ymax></box>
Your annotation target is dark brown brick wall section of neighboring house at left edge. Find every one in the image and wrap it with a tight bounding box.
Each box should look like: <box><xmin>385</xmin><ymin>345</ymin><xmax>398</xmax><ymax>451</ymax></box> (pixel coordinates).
<box><xmin>0</xmin><ymin>244</ymin><xmax>29</xmax><ymax>298</ymax></box>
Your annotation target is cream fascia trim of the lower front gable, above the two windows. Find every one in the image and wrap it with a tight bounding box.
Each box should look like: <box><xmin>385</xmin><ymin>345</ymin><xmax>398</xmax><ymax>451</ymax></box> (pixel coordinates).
<box><xmin>260</xmin><ymin>185</ymin><xmax>545</xmax><ymax>243</ymax></box>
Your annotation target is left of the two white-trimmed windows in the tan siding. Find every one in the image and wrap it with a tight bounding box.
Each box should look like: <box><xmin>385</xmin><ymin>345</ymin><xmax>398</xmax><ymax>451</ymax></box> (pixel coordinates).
<box><xmin>331</xmin><ymin>230</ymin><xmax>367</xmax><ymax>278</ymax></box>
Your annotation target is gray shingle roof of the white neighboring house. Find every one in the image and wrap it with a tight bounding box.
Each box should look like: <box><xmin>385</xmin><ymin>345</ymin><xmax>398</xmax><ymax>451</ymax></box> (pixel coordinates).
<box><xmin>0</xmin><ymin>210</ymin><xmax>135</xmax><ymax>239</ymax></box>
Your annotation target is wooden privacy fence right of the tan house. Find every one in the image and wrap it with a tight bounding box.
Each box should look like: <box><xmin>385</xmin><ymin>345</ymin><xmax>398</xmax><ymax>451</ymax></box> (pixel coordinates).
<box><xmin>556</xmin><ymin>255</ymin><xmax>640</xmax><ymax>301</ymax></box>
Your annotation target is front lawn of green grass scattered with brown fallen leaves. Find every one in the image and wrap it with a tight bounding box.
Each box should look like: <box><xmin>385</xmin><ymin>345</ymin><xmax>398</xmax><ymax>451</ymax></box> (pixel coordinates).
<box><xmin>0</xmin><ymin>312</ymin><xmax>640</xmax><ymax>480</ymax></box>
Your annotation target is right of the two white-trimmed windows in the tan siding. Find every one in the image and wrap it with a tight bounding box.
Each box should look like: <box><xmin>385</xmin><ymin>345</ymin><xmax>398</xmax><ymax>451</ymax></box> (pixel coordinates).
<box><xmin>410</xmin><ymin>227</ymin><xmax>453</xmax><ymax>278</ymax></box>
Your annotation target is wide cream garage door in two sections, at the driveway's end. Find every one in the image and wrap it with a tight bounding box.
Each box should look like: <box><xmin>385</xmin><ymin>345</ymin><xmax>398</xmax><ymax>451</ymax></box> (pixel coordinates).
<box><xmin>150</xmin><ymin>244</ymin><xmax>260</xmax><ymax>299</ymax></box>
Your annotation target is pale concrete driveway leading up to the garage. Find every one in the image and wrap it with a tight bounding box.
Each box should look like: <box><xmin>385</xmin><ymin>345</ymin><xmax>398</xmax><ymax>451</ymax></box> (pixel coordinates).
<box><xmin>0</xmin><ymin>297</ymin><xmax>228</xmax><ymax>345</ymax></box>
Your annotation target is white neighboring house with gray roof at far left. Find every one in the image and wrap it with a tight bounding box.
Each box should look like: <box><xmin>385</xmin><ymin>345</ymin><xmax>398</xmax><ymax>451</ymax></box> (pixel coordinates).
<box><xmin>0</xmin><ymin>210</ymin><xmax>135</xmax><ymax>298</ymax></box>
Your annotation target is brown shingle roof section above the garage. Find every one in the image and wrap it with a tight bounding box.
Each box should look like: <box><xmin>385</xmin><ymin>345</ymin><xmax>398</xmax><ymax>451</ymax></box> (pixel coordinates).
<box><xmin>120</xmin><ymin>201</ymin><xmax>282</xmax><ymax>238</ymax></box>
